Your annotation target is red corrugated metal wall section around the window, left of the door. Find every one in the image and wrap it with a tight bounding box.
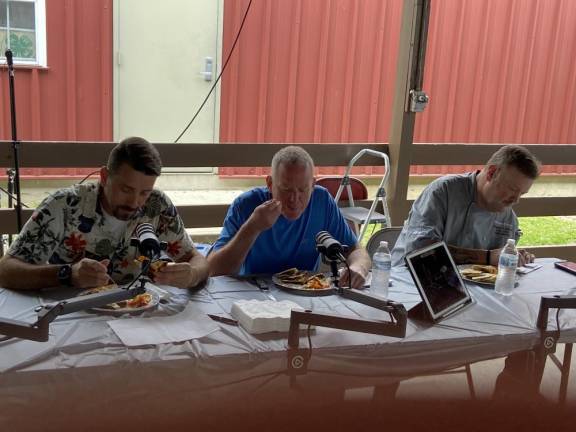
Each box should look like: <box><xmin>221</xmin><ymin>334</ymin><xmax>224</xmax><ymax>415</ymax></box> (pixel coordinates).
<box><xmin>0</xmin><ymin>0</ymin><xmax>112</xmax><ymax>176</ymax></box>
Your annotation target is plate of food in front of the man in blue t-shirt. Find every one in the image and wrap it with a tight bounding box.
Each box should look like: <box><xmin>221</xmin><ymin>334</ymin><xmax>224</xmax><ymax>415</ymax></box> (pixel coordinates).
<box><xmin>272</xmin><ymin>267</ymin><xmax>336</xmax><ymax>296</ymax></box>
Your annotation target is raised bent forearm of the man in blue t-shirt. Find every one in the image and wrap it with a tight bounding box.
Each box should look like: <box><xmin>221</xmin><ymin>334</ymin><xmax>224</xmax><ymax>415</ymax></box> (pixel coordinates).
<box><xmin>208</xmin><ymin>222</ymin><xmax>260</xmax><ymax>276</ymax></box>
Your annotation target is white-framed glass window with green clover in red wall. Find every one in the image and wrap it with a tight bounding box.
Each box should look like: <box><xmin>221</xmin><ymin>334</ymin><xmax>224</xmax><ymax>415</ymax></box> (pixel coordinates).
<box><xmin>0</xmin><ymin>0</ymin><xmax>46</xmax><ymax>66</ymax></box>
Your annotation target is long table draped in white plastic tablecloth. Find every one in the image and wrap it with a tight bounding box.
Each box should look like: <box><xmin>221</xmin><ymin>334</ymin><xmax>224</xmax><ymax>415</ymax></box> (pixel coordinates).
<box><xmin>0</xmin><ymin>259</ymin><xmax>576</xmax><ymax>430</ymax></box>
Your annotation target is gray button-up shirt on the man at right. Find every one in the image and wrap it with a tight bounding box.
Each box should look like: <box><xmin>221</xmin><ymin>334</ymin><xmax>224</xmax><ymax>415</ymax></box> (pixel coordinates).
<box><xmin>392</xmin><ymin>172</ymin><xmax>519</xmax><ymax>266</ymax></box>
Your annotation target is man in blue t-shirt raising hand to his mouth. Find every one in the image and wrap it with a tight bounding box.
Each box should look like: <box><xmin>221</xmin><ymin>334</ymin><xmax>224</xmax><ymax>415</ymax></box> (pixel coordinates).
<box><xmin>208</xmin><ymin>146</ymin><xmax>370</xmax><ymax>288</ymax></box>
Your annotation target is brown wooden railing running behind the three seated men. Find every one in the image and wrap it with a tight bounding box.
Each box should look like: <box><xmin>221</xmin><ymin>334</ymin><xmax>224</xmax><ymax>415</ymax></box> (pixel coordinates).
<box><xmin>0</xmin><ymin>141</ymin><xmax>576</xmax><ymax>259</ymax></box>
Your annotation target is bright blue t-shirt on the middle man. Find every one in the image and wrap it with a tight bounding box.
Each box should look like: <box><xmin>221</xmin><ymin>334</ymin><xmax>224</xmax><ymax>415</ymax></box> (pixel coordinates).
<box><xmin>213</xmin><ymin>186</ymin><xmax>356</xmax><ymax>275</ymax></box>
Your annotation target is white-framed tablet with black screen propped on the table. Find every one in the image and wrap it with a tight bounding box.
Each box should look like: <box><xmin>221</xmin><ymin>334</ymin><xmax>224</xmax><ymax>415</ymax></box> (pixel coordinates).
<box><xmin>405</xmin><ymin>242</ymin><xmax>472</xmax><ymax>321</ymax></box>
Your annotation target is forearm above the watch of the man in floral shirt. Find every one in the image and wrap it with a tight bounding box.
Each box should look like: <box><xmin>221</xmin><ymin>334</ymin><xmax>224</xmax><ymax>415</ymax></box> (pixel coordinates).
<box><xmin>0</xmin><ymin>255</ymin><xmax>60</xmax><ymax>290</ymax></box>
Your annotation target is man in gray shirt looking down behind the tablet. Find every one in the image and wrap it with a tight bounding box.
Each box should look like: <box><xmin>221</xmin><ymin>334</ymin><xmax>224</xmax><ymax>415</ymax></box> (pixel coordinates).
<box><xmin>392</xmin><ymin>145</ymin><xmax>540</xmax><ymax>266</ymax></box>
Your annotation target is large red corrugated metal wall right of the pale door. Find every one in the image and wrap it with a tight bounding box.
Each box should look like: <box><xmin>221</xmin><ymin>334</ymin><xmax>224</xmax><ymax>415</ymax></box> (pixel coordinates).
<box><xmin>220</xmin><ymin>0</ymin><xmax>576</xmax><ymax>175</ymax></box>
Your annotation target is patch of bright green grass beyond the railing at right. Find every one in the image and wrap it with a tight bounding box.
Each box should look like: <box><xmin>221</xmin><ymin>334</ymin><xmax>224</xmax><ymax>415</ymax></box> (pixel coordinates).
<box><xmin>518</xmin><ymin>216</ymin><xmax>576</xmax><ymax>246</ymax></box>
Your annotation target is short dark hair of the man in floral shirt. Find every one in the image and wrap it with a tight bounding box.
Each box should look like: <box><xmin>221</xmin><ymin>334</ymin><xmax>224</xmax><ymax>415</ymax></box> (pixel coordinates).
<box><xmin>106</xmin><ymin>137</ymin><xmax>162</xmax><ymax>177</ymax></box>
